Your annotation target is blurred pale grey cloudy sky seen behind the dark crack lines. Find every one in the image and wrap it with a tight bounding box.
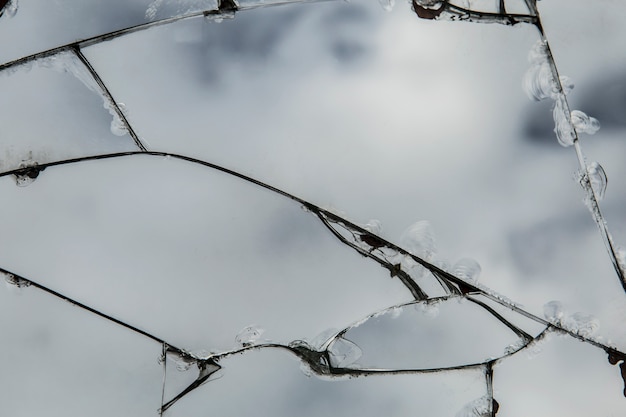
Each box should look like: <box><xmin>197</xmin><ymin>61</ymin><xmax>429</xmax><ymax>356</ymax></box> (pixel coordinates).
<box><xmin>0</xmin><ymin>0</ymin><xmax>626</xmax><ymax>417</ymax></box>
